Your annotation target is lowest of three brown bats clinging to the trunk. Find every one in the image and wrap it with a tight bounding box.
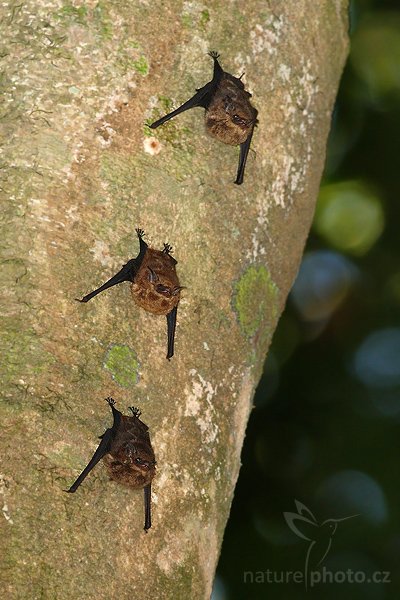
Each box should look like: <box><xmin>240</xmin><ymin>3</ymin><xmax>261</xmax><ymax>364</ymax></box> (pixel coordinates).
<box><xmin>65</xmin><ymin>398</ymin><xmax>156</xmax><ymax>533</ymax></box>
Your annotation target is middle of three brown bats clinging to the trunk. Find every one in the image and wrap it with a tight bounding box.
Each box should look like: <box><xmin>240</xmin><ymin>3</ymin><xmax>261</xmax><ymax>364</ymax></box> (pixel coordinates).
<box><xmin>76</xmin><ymin>229</ymin><xmax>184</xmax><ymax>360</ymax></box>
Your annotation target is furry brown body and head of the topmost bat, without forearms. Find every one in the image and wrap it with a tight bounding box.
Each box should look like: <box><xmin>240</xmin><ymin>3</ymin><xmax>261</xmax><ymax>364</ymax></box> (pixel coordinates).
<box><xmin>205</xmin><ymin>78</ymin><xmax>257</xmax><ymax>146</ymax></box>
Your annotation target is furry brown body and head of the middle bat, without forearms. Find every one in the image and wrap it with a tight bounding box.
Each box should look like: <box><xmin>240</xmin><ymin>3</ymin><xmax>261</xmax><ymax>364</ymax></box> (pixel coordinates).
<box><xmin>132</xmin><ymin>249</ymin><xmax>183</xmax><ymax>315</ymax></box>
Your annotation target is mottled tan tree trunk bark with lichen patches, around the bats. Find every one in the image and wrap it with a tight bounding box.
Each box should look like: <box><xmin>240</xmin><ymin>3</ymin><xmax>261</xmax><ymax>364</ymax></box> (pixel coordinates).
<box><xmin>0</xmin><ymin>0</ymin><xmax>347</xmax><ymax>600</ymax></box>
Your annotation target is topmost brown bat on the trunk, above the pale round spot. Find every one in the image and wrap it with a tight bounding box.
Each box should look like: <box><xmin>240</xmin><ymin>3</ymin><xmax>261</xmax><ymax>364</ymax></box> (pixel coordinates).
<box><xmin>150</xmin><ymin>52</ymin><xmax>258</xmax><ymax>185</ymax></box>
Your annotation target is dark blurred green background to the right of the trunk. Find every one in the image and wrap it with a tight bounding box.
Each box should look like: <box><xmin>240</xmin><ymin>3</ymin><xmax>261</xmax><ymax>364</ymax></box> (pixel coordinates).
<box><xmin>213</xmin><ymin>0</ymin><xmax>400</xmax><ymax>600</ymax></box>
